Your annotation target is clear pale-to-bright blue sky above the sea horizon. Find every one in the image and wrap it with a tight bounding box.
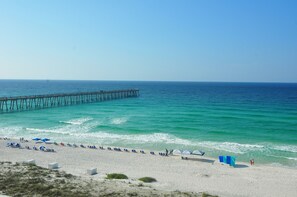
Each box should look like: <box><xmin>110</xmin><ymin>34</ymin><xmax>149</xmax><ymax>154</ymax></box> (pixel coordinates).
<box><xmin>0</xmin><ymin>0</ymin><xmax>297</xmax><ymax>82</ymax></box>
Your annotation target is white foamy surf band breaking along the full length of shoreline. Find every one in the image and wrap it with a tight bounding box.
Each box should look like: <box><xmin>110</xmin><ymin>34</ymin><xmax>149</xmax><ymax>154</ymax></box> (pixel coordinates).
<box><xmin>0</xmin><ymin>126</ymin><xmax>297</xmax><ymax>161</ymax></box>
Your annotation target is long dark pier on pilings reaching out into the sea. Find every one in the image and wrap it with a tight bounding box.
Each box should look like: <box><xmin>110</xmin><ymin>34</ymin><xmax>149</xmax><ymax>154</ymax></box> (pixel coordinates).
<box><xmin>0</xmin><ymin>89</ymin><xmax>139</xmax><ymax>113</ymax></box>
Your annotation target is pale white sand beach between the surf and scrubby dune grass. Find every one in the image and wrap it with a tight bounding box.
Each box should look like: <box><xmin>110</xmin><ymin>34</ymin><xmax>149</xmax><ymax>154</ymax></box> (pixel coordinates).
<box><xmin>0</xmin><ymin>140</ymin><xmax>297</xmax><ymax>197</ymax></box>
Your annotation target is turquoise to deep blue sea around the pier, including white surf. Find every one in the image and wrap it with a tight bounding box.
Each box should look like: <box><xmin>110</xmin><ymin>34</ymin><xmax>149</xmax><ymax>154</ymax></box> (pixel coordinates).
<box><xmin>0</xmin><ymin>80</ymin><xmax>297</xmax><ymax>167</ymax></box>
